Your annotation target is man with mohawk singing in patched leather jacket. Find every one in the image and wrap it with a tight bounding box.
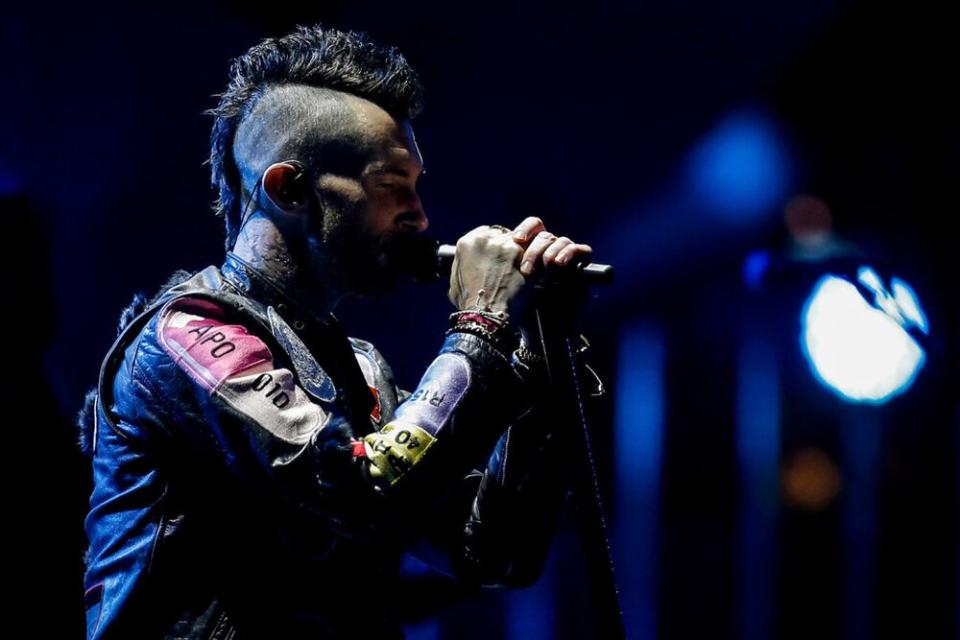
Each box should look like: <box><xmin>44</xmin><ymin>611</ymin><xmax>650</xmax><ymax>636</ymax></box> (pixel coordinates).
<box><xmin>81</xmin><ymin>26</ymin><xmax>590</xmax><ymax>639</ymax></box>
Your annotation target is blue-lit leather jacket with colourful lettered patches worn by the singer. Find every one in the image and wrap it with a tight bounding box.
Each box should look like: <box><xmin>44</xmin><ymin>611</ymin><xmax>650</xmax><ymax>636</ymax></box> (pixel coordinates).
<box><xmin>81</xmin><ymin>254</ymin><xmax>568</xmax><ymax>639</ymax></box>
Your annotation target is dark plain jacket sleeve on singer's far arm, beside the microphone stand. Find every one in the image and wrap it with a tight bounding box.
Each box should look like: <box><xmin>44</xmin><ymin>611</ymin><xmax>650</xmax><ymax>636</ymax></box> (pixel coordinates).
<box><xmin>406</xmin><ymin>339</ymin><xmax>604</xmax><ymax>587</ymax></box>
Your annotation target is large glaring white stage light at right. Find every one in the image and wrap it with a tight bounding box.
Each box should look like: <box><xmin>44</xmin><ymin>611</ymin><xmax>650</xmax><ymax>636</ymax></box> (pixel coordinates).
<box><xmin>801</xmin><ymin>270</ymin><xmax>925</xmax><ymax>404</ymax></box>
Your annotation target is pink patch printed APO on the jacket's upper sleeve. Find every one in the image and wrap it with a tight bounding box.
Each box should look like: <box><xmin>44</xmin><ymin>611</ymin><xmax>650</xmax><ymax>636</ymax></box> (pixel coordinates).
<box><xmin>159</xmin><ymin>300</ymin><xmax>273</xmax><ymax>393</ymax></box>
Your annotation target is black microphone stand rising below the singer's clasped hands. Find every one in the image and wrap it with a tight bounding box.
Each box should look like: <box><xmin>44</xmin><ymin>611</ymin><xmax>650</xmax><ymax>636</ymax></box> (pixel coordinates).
<box><xmin>531</xmin><ymin>267</ymin><xmax>626</xmax><ymax>640</ymax></box>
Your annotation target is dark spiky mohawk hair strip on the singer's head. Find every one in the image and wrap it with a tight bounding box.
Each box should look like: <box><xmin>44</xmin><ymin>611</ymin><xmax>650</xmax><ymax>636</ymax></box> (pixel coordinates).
<box><xmin>206</xmin><ymin>24</ymin><xmax>423</xmax><ymax>251</ymax></box>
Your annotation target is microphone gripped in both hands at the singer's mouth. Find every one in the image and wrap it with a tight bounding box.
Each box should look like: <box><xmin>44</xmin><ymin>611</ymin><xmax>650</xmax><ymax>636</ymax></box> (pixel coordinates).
<box><xmin>390</xmin><ymin>235</ymin><xmax>614</xmax><ymax>285</ymax></box>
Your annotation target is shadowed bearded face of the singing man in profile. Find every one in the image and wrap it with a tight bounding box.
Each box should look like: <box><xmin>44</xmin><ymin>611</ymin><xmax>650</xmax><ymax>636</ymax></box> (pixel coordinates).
<box><xmin>308</xmin><ymin>101</ymin><xmax>428</xmax><ymax>296</ymax></box>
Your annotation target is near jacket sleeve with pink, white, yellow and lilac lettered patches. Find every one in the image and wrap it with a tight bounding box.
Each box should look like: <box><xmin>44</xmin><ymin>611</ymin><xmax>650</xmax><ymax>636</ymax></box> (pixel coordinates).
<box><xmin>120</xmin><ymin>298</ymin><xmax>529</xmax><ymax>539</ymax></box>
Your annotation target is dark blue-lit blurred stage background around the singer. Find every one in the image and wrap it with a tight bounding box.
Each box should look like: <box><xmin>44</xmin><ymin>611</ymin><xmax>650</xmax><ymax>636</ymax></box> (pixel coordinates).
<box><xmin>0</xmin><ymin>0</ymin><xmax>960</xmax><ymax>639</ymax></box>
